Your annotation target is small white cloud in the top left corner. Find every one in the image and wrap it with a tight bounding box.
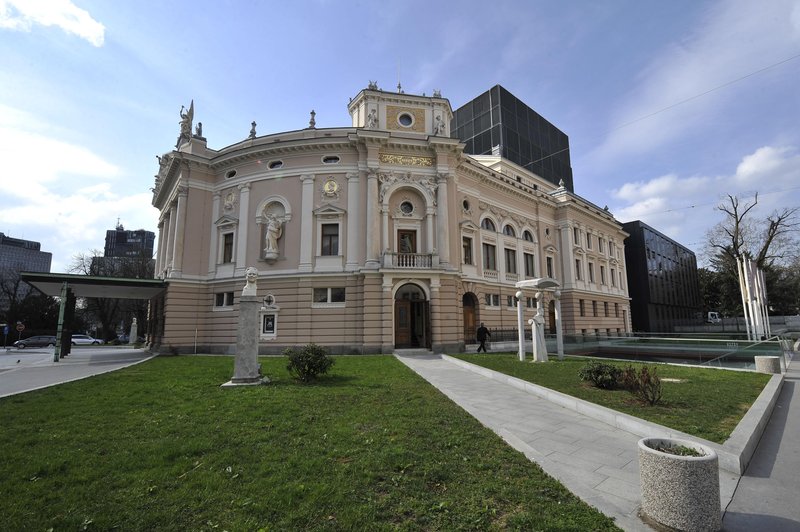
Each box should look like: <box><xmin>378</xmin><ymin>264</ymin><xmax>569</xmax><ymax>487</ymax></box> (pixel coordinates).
<box><xmin>0</xmin><ymin>0</ymin><xmax>105</xmax><ymax>47</ymax></box>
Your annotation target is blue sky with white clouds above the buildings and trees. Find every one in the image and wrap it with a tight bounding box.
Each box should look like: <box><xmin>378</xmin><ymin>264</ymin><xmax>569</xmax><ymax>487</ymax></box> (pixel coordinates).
<box><xmin>0</xmin><ymin>0</ymin><xmax>800</xmax><ymax>271</ymax></box>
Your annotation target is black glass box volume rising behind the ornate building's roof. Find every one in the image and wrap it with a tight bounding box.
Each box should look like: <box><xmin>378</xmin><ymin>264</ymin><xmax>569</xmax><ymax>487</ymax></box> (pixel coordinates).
<box><xmin>450</xmin><ymin>85</ymin><xmax>575</xmax><ymax>192</ymax></box>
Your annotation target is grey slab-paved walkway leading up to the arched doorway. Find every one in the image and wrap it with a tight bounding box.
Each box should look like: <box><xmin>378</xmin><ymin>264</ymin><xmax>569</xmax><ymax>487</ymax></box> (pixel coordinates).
<box><xmin>395</xmin><ymin>355</ymin><xmax>739</xmax><ymax>531</ymax></box>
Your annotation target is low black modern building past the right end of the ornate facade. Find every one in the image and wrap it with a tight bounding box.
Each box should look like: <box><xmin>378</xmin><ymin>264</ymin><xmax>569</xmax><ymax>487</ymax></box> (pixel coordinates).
<box><xmin>622</xmin><ymin>220</ymin><xmax>702</xmax><ymax>332</ymax></box>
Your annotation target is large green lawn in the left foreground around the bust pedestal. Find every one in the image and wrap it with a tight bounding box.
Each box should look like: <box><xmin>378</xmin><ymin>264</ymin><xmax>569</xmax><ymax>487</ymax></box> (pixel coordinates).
<box><xmin>0</xmin><ymin>356</ymin><xmax>615</xmax><ymax>531</ymax></box>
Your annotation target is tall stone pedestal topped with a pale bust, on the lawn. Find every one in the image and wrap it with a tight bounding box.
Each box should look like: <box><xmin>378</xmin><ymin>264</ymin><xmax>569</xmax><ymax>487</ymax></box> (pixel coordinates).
<box><xmin>223</xmin><ymin>266</ymin><xmax>269</xmax><ymax>386</ymax></box>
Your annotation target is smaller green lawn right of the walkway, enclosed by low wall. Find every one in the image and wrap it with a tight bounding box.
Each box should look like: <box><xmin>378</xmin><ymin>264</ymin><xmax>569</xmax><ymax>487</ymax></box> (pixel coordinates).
<box><xmin>457</xmin><ymin>354</ymin><xmax>770</xmax><ymax>443</ymax></box>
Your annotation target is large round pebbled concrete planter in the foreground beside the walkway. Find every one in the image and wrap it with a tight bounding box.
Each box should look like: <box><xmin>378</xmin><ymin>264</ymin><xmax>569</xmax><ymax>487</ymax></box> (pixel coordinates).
<box><xmin>639</xmin><ymin>438</ymin><xmax>722</xmax><ymax>530</ymax></box>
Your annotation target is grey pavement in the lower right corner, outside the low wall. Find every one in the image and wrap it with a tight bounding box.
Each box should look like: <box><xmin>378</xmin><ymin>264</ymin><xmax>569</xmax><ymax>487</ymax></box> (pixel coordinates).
<box><xmin>722</xmin><ymin>361</ymin><xmax>800</xmax><ymax>532</ymax></box>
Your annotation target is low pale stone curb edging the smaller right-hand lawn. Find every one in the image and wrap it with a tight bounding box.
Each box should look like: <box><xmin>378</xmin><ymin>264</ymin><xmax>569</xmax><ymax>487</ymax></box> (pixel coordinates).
<box><xmin>442</xmin><ymin>355</ymin><xmax>783</xmax><ymax>475</ymax></box>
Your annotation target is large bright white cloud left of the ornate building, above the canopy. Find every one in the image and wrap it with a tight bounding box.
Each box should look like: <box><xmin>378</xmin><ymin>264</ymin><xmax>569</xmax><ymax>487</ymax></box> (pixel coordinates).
<box><xmin>0</xmin><ymin>106</ymin><xmax>157</xmax><ymax>271</ymax></box>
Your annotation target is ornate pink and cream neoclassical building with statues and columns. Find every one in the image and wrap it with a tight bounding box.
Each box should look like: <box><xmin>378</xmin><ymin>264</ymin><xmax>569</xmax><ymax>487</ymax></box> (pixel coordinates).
<box><xmin>150</xmin><ymin>84</ymin><xmax>630</xmax><ymax>354</ymax></box>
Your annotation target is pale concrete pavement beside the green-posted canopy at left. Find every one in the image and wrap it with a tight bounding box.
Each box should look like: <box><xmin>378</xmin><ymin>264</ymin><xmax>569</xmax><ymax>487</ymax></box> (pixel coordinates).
<box><xmin>0</xmin><ymin>346</ymin><xmax>151</xmax><ymax>397</ymax></box>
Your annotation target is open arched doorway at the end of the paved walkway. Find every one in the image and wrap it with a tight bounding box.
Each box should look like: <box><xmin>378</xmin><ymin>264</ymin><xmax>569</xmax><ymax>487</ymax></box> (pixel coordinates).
<box><xmin>394</xmin><ymin>283</ymin><xmax>431</xmax><ymax>349</ymax></box>
